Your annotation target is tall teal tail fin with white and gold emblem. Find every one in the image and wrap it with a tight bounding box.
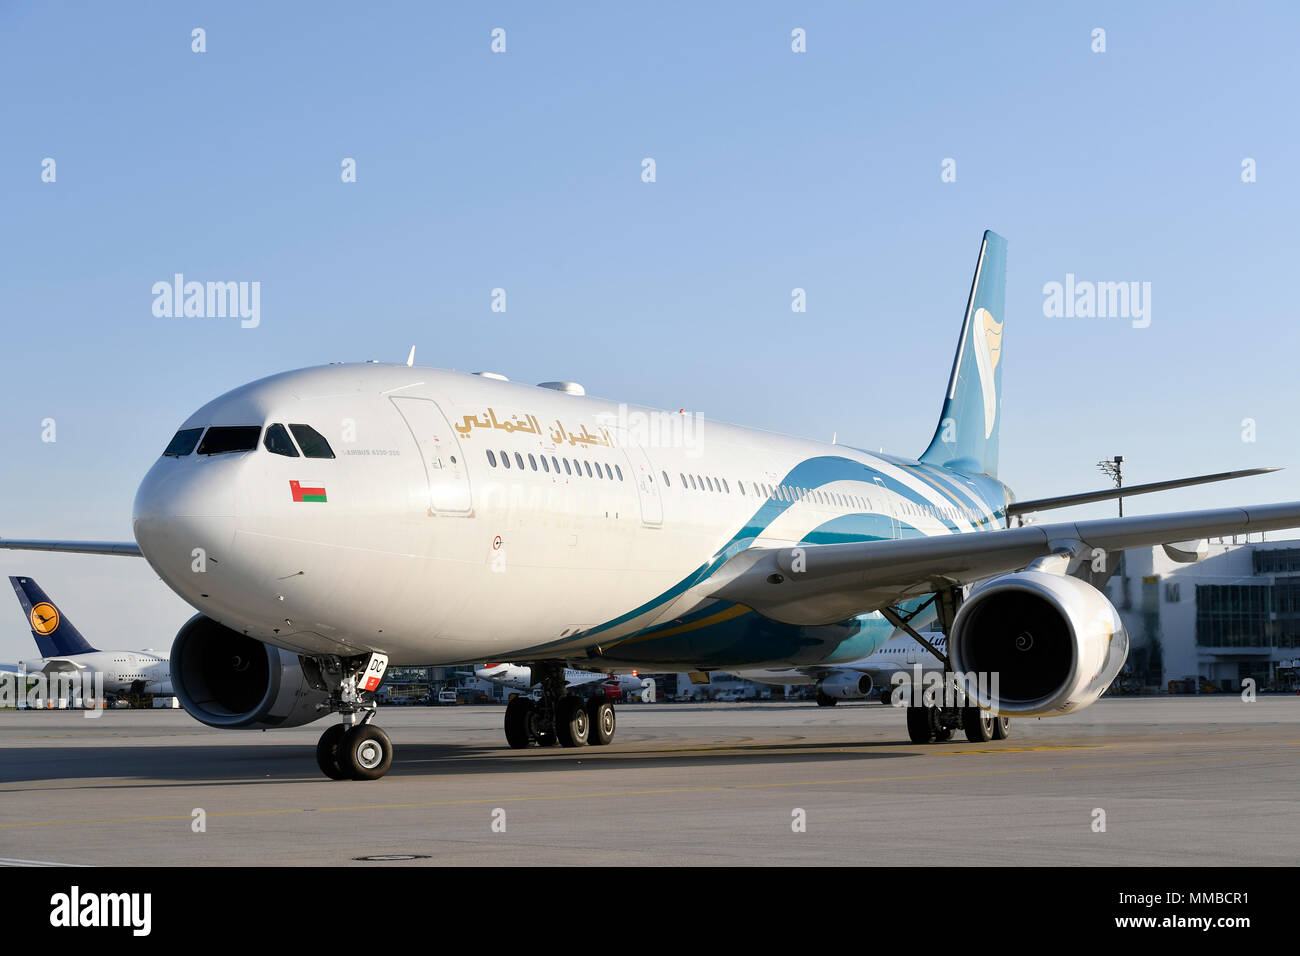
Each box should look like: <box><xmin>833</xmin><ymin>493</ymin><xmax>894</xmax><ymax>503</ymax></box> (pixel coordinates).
<box><xmin>920</xmin><ymin>232</ymin><xmax>1006</xmax><ymax>477</ymax></box>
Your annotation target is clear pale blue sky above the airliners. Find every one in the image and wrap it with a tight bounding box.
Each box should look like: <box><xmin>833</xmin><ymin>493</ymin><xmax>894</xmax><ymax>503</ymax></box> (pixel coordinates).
<box><xmin>0</xmin><ymin>3</ymin><xmax>1300</xmax><ymax>661</ymax></box>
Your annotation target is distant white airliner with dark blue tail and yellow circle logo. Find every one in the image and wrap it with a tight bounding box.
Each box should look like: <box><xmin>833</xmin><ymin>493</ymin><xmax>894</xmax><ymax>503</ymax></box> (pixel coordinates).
<box><xmin>9</xmin><ymin>576</ymin><xmax>173</xmax><ymax>697</ymax></box>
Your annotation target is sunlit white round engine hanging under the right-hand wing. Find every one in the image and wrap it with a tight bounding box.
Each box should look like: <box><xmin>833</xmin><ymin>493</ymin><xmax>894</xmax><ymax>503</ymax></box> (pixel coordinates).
<box><xmin>948</xmin><ymin>571</ymin><xmax>1128</xmax><ymax>717</ymax></box>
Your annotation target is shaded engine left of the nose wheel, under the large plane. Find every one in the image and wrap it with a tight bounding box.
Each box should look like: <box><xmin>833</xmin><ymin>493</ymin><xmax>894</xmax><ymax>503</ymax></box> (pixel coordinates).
<box><xmin>172</xmin><ymin>614</ymin><xmax>329</xmax><ymax>730</ymax></box>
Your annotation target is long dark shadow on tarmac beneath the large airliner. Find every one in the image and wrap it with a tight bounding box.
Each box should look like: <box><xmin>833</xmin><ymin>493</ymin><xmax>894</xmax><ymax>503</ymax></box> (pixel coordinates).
<box><xmin>0</xmin><ymin>740</ymin><xmax>915</xmax><ymax>793</ymax></box>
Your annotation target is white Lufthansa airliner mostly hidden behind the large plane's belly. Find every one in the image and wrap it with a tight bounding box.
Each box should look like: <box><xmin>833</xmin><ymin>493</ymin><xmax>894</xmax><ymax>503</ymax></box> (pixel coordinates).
<box><xmin>736</xmin><ymin>633</ymin><xmax>948</xmax><ymax>708</ymax></box>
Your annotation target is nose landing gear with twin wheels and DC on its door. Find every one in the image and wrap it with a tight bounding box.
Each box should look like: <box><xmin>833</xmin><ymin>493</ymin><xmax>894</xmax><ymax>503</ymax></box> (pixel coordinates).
<box><xmin>311</xmin><ymin>654</ymin><xmax>393</xmax><ymax>780</ymax></box>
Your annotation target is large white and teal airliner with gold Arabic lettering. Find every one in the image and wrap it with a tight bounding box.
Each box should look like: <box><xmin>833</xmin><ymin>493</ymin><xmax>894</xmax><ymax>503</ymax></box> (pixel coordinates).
<box><xmin>3</xmin><ymin>233</ymin><xmax>1300</xmax><ymax>779</ymax></box>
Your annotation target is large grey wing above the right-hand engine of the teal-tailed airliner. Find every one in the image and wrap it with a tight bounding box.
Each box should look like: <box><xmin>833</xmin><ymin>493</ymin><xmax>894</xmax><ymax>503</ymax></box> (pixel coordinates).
<box><xmin>710</xmin><ymin>502</ymin><xmax>1300</xmax><ymax>624</ymax></box>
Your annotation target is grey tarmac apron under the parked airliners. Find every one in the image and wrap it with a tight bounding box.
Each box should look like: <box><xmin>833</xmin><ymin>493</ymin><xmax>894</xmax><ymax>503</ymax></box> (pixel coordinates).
<box><xmin>0</xmin><ymin>696</ymin><xmax>1300</xmax><ymax>866</ymax></box>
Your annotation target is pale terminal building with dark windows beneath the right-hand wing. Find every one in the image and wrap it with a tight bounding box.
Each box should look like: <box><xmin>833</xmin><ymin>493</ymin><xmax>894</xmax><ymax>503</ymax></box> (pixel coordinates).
<box><xmin>1106</xmin><ymin>535</ymin><xmax>1300</xmax><ymax>692</ymax></box>
